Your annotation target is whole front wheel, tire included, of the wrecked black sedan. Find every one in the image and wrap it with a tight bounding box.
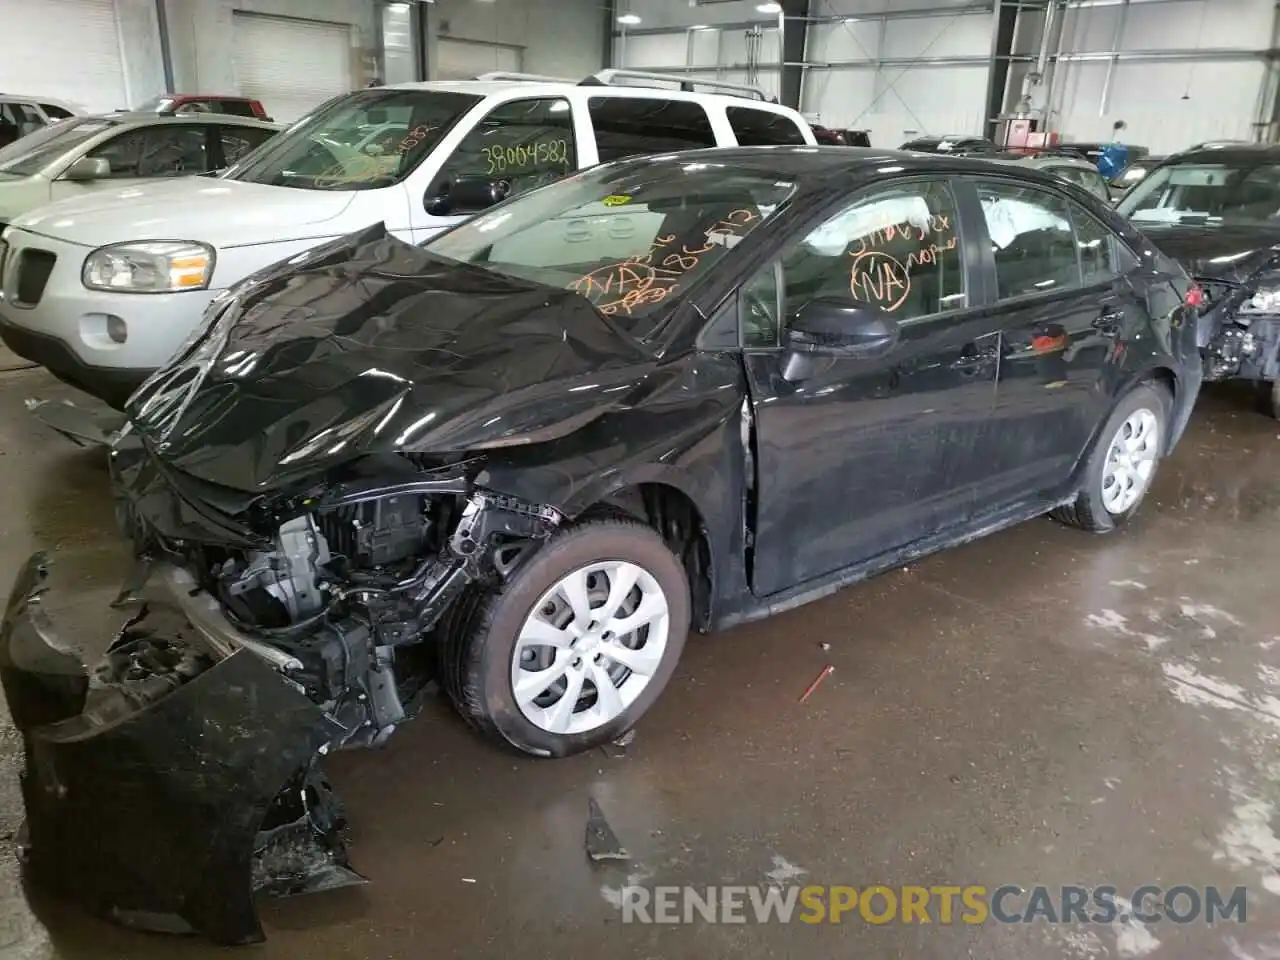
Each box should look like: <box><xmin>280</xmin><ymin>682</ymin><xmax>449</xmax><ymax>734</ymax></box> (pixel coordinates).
<box><xmin>438</xmin><ymin>520</ymin><xmax>690</xmax><ymax>758</ymax></box>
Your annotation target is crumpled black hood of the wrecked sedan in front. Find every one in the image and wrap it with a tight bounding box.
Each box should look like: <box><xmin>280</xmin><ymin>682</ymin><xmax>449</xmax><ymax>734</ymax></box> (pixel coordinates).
<box><xmin>129</xmin><ymin>225</ymin><xmax>655</xmax><ymax>490</ymax></box>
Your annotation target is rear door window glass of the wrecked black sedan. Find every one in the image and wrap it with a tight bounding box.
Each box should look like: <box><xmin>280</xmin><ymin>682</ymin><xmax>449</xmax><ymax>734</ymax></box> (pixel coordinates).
<box><xmin>977</xmin><ymin>183</ymin><xmax>1080</xmax><ymax>300</ymax></box>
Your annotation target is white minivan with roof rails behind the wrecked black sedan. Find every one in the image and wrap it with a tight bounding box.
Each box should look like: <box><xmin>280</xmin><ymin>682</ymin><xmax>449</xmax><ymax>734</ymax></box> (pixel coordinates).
<box><xmin>0</xmin><ymin>70</ymin><xmax>815</xmax><ymax>422</ymax></box>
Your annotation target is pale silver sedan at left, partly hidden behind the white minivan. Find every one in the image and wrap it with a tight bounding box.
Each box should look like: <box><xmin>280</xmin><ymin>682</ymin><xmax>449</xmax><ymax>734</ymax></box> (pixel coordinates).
<box><xmin>0</xmin><ymin>114</ymin><xmax>283</xmax><ymax>230</ymax></box>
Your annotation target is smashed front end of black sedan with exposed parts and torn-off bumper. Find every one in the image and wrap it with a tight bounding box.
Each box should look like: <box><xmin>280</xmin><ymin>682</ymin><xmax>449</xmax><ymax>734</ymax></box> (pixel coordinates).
<box><xmin>0</xmin><ymin>442</ymin><xmax>561</xmax><ymax>943</ymax></box>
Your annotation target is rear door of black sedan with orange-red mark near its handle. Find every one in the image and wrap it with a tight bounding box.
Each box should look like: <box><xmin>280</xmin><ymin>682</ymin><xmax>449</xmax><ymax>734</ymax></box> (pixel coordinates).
<box><xmin>970</xmin><ymin>178</ymin><xmax>1144</xmax><ymax>500</ymax></box>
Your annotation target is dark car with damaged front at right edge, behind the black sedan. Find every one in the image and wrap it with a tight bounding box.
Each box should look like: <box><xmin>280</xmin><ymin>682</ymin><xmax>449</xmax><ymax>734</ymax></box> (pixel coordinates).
<box><xmin>1116</xmin><ymin>143</ymin><xmax>1280</xmax><ymax>419</ymax></box>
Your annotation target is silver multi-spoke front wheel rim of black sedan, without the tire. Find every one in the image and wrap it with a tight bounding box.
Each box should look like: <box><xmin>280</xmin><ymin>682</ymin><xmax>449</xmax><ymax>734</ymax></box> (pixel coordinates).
<box><xmin>511</xmin><ymin>561</ymin><xmax>671</xmax><ymax>735</ymax></box>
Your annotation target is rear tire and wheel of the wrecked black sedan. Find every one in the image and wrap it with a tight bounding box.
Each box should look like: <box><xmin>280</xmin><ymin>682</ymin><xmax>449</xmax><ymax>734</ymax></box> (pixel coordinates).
<box><xmin>1050</xmin><ymin>381</ymin><xmax>1174</xmax><ymax>534</ymax></box>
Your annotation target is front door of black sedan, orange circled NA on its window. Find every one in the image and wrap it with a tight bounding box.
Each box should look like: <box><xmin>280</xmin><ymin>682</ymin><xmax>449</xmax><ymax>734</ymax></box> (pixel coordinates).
<box><xmin>742</xmin><ymin>172</ymin><xmax>998</xmax><ymax>595</ymax></box>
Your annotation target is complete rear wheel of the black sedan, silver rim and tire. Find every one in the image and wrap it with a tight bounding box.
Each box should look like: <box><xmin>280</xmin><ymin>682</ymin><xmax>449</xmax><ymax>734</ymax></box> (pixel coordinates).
<box><xmin>1052</xmin><ymin>383</ymin><xmax>1172</xmax><ymax>534</ymax></box>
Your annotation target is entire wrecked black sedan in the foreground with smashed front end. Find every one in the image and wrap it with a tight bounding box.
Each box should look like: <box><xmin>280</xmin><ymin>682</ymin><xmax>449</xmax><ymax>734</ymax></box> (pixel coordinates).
<box><xmin>0</xmin><ymin>147</ymin><xmax>1201</xmax><ymax>942</ymax></box>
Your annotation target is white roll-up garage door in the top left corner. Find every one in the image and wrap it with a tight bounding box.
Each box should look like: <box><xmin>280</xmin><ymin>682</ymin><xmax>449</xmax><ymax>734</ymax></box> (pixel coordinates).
<box><xmin>0</xmin><ymin>0</ymin><xmax>128</xmax><ymax>113</ymax></box>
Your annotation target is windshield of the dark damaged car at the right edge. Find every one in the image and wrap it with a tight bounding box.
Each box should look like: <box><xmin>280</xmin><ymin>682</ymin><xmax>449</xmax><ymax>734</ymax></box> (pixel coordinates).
<box><xmin>1116</xmin><ymin>161</ymin><xmax>1280</xmax><ymax>224</ymax></box>
